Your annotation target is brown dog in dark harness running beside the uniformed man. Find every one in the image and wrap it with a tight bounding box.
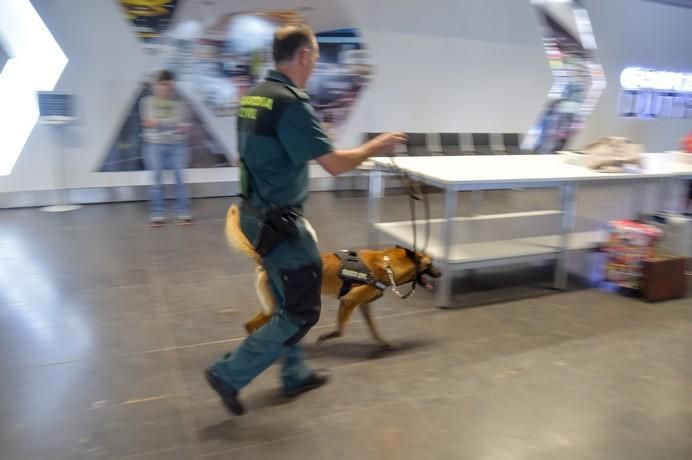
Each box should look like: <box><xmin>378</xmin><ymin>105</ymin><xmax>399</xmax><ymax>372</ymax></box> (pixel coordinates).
<box><xmin>226</xmin><ymin>205</ymin><xmax>440</xmax><ymax>349</ymax></box>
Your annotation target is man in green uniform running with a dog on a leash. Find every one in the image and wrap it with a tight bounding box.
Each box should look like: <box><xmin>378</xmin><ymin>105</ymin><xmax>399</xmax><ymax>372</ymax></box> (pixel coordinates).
<box><xmin>205</xmin><ymin>25</ymin><xmax>405</xmax><ymax>415</ymax></box>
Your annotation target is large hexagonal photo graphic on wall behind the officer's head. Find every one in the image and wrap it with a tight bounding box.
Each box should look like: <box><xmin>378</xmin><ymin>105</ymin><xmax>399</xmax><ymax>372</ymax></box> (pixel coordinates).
<box><xmin>158</xmin><ymin>11</ymin><xmax>373</xmax><ymax>137</ymax></box>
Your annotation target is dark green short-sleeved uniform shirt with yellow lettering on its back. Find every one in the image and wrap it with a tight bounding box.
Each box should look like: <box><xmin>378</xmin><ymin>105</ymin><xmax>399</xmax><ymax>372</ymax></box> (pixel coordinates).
<box><xmin>238</xmin><ymin>70</ymin><xmax>334</xmax><ymax>209</ymax></box>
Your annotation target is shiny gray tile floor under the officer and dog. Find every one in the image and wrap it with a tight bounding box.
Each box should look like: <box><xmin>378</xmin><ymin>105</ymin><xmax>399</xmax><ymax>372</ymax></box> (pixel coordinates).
<box><xmin>0</xmin><ymin>192</ymin><xmax>692</xmax><ymax>460</ymax></box>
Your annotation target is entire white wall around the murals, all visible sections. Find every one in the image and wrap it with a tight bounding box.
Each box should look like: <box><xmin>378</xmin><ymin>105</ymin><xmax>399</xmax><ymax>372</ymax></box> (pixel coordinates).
<box><xmin>0</xmin><ymin>0</ymin><xmax>692</xmax><ymax>196</ymax></box>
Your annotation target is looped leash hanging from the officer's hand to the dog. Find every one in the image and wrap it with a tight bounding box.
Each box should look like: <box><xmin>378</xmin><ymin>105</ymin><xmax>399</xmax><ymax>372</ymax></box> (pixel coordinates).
<box><xmin>384</xmin><ymin>155</ymin><xmax>431</xmax><ymax>300</ymax></box>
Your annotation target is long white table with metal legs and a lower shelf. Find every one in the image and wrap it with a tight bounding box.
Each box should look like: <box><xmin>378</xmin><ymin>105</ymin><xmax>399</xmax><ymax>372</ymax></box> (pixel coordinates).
<box><xmin>368</xmin><ymin>154</ymin><xmax>692</xmax><ymax>307</ymax></box>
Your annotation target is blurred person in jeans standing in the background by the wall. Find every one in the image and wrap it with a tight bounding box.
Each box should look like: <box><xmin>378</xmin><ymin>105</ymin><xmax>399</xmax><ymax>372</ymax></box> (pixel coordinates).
<box><xmin>139</xmin><ymin>70</ymin><xmax>192</xmax><ymax>227</ymax></box>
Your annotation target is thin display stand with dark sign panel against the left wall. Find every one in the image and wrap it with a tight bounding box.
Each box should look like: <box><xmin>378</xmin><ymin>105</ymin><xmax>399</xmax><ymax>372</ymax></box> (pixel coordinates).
<box><xmin>38</xmin><ymin>92</ymin><xmax>82</xmax><ymax>212</ymax></box>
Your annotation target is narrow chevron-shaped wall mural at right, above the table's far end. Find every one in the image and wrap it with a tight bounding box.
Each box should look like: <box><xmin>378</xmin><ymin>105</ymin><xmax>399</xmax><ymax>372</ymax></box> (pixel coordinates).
<box><xmin>522</xmin><ymin>0</ymin><xmax>606</xmax><ymax>153</ymax></box>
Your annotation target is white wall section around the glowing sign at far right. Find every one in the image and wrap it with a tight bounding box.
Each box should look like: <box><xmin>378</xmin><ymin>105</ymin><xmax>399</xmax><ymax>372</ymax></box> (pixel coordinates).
<box><xmin>577</xmin><ymin>0</ymin><xmax>692</xmax><ymax>152</ymax></box>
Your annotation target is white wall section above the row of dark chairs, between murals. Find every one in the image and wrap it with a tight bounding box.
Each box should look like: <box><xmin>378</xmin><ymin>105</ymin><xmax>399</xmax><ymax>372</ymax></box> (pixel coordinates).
<box><xmin>344</xmin><ymin>0</ymin><xmax>550</xmax><ymax>145</ymax></box>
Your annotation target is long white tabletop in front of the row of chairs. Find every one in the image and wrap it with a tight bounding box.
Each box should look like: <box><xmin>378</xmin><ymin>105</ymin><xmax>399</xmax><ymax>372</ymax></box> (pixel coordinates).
<box><xmin>372</xmin><ymin>153</ymin><xmax>692</xmax><ymax>190</ymax></box>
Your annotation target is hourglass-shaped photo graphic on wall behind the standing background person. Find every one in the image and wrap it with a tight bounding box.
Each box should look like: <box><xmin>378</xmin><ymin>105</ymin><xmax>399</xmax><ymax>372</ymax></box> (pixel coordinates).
<box><xmin>99</xmin><ymin>0</ymin><xmax>231</xmax><ymax>172</ymax></box>
